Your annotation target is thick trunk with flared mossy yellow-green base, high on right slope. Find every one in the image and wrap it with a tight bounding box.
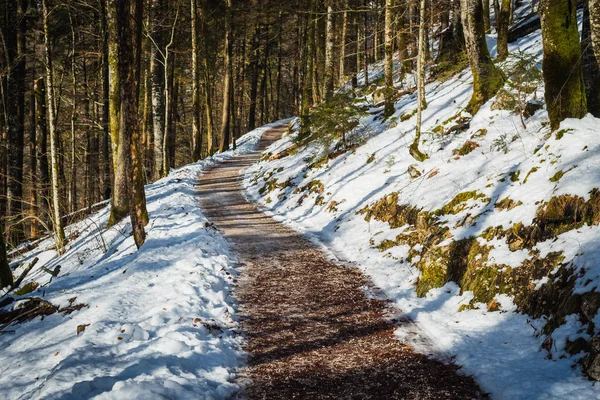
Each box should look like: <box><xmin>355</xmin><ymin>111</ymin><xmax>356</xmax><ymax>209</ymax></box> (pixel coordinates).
<box><xmin>461</xmin><ymin>0</ymin><xmax>504</xmax><ymax>114</ymax></box>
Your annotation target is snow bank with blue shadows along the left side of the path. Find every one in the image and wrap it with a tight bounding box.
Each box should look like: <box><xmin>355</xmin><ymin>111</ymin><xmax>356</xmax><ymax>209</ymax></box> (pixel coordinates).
<box><xmin>0</xmin><ymin>124</ymin><xmax>288</xmax><ymax>399</ymax></box>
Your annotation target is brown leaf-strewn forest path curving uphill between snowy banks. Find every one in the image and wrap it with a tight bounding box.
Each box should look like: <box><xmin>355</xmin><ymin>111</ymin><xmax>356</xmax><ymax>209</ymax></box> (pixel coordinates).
<box><xmin>199</xmin><ymin>126</ymin><xmax>485</xmax><ymax>399</ymax></box>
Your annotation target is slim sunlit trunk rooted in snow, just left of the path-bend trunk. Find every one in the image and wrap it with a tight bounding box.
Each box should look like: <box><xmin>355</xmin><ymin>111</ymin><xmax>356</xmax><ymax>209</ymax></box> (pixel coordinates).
<box><xmin>190</xmin><ymin>0</ymin><xmax>202</xmax><ymax>162</ymax></box>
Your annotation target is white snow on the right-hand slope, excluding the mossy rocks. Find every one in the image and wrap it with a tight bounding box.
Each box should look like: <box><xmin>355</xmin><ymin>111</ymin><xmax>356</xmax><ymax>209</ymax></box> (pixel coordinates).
<box><xmin>245</xmin><ymin>26</ymin><xmax>600</xmax><ymax>399</ymax></box>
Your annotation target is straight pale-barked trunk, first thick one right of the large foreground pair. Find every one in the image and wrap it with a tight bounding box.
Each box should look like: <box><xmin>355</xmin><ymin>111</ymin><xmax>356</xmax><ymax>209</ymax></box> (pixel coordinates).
<box><xmin>150</xmin><ymin>0</ymin><xmax>166</xmax><ymax>180</ymax></box>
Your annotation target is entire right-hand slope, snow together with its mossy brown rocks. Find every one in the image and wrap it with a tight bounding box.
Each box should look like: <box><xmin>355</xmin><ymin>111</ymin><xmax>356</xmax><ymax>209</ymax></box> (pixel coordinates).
<box><xmin>245</xmin><ymin>28</ymin><xmax>600</xmax><ymax>399</ymax></box>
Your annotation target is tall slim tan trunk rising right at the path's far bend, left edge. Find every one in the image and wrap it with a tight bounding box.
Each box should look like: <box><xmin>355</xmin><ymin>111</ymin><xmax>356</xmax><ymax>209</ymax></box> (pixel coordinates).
<box><xmin>219</xmin><ymin>0</ymin><xmax>233</xmax><ymax>153</ymax></box>
